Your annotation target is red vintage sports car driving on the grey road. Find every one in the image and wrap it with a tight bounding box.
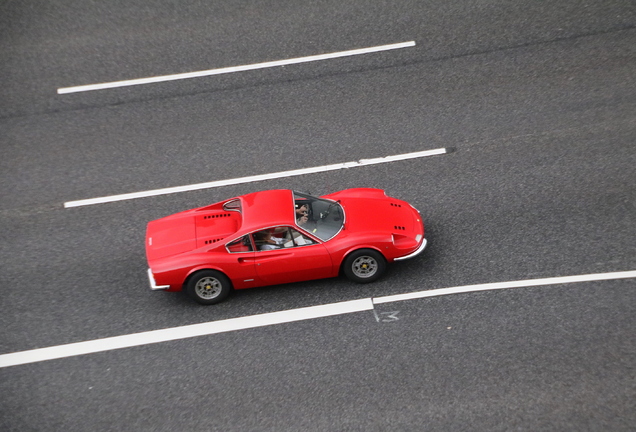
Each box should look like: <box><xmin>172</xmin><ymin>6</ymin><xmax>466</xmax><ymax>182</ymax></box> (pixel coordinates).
<box><xmin>146</xmin><ymin>188</ymin><xmax>426</xmax><ymax>304</ymax></box>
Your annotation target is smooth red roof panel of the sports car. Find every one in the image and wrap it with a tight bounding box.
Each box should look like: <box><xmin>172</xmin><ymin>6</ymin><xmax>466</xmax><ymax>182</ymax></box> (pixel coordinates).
<box><xmin>240</xmin><ymin>189</ymin><xmax>296</xmax><ymax>232</ymax></box>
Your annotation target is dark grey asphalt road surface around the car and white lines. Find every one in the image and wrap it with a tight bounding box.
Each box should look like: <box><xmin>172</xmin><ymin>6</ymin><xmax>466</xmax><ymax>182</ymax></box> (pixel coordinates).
<box><xmin>0</xmin><ymin>0</ymin><xmax>636</xmax><ymax>431</ymax></box>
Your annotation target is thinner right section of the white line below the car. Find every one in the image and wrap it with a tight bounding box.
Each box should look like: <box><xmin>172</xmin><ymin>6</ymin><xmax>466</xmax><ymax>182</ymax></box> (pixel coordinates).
<box><xmin>373</xmin><ymin>270</ymin><xmax>636</xmax><ymax>304</ymax></box>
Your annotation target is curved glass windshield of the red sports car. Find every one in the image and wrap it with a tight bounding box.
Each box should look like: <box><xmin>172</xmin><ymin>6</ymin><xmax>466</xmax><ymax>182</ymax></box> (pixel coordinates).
<box><xmin>294</xmin><ymin>191</ymin><xmax>344</xmax><ymax>241</ymax></box>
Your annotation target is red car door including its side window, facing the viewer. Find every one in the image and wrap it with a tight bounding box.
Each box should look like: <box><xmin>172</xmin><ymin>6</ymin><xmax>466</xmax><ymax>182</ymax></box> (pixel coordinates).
<box><xmin>253</xmin><ymin>226</ymin><xmax>332</xmax><ymax>285</ymax></box>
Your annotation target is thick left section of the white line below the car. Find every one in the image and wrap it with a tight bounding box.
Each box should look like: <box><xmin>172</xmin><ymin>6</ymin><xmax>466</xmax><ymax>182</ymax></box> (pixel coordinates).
<box><xmin>0</xmin><ymin>298</ymin><xmax>373</xmax><ymax>368</ymax></box>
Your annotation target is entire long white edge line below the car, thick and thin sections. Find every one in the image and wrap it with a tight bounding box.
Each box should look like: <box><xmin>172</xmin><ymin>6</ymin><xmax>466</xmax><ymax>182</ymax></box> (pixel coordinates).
<box><xmin>0</xmin><ymin>270</ymin><xmax>636</xmax><ymax>368</ymax></box>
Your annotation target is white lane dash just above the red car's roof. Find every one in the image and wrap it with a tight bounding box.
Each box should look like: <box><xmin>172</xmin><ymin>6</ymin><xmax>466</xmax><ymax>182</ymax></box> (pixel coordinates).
<box><xmin>64</xmin><ymin>148</ymin><xmax>446</xmax><ymax>208</ymax></box>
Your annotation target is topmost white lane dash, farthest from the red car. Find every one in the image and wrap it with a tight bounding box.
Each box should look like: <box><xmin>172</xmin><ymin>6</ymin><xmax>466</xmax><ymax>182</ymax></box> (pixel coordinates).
<box><xmin>57</xmin><ymin>41</ymin><xmax>415</xmax><ymax>94</ymax></box>
